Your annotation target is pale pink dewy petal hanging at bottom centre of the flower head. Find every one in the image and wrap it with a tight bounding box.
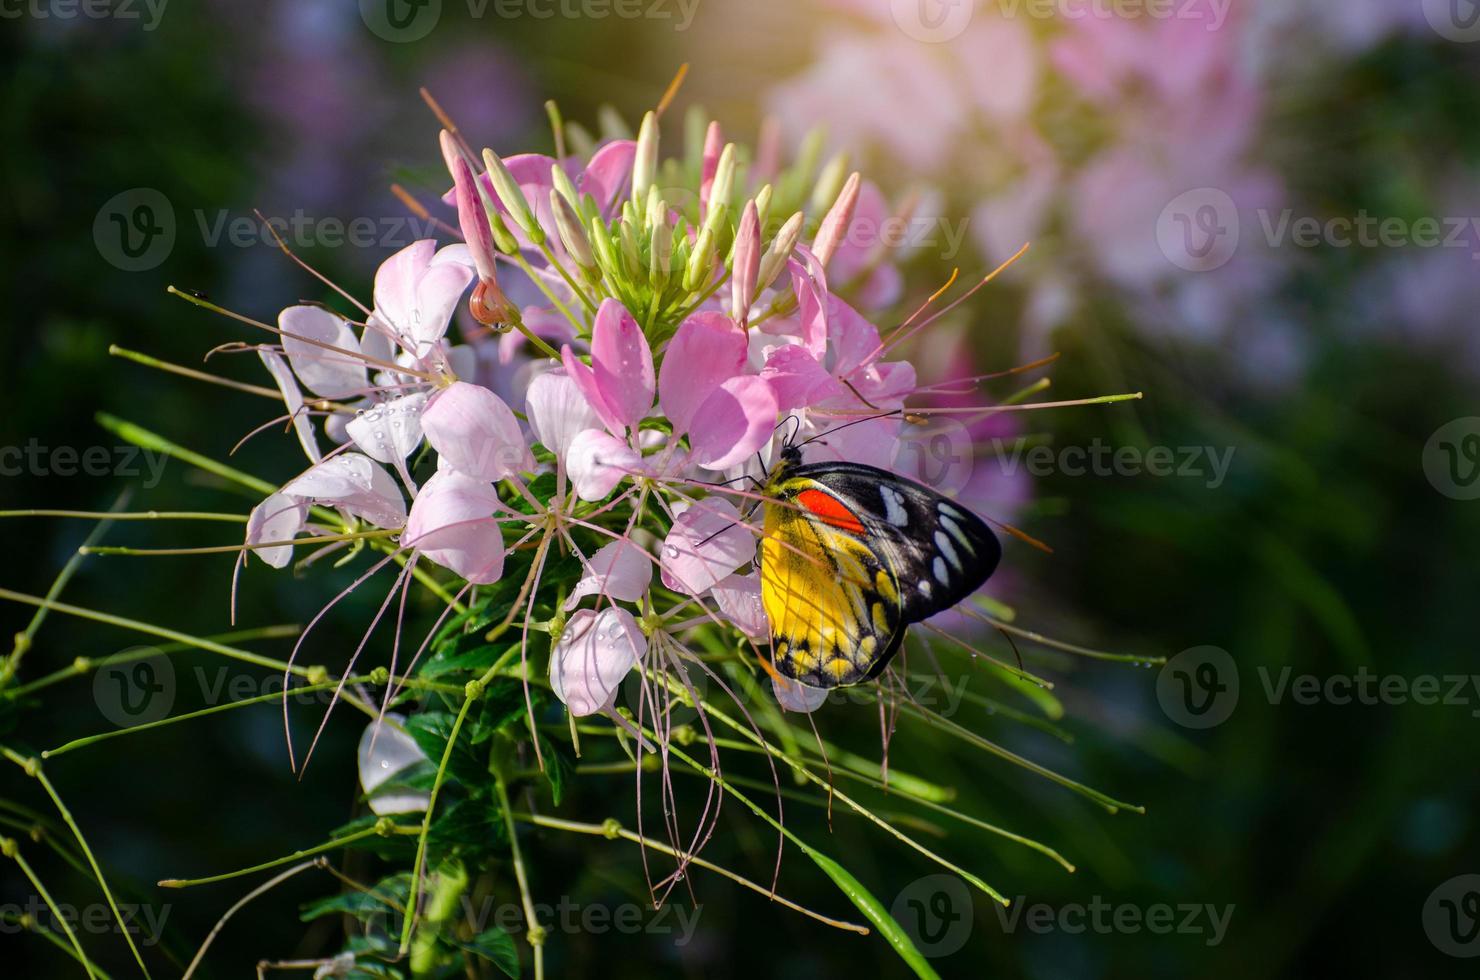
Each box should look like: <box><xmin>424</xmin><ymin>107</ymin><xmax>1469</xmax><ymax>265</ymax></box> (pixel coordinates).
<box><xmin>551</xmin><ymin>605</ymin><xmax>647</xmax><ymax>718</ymax></box>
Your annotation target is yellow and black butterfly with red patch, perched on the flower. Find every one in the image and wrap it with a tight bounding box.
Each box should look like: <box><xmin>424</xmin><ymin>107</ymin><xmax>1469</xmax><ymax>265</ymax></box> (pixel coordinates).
<box><xmin>761</xmin><ymin>444</ymin><xmax>1002</xmax><ymax>688</ymax></box>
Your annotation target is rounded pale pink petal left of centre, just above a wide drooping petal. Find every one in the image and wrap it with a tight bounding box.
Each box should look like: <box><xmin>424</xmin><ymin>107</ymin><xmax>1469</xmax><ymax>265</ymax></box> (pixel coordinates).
<box><xmin>422</xmin><ymin>380</ymin><xmax>534</xmax><ymax>483</ymax></box>
